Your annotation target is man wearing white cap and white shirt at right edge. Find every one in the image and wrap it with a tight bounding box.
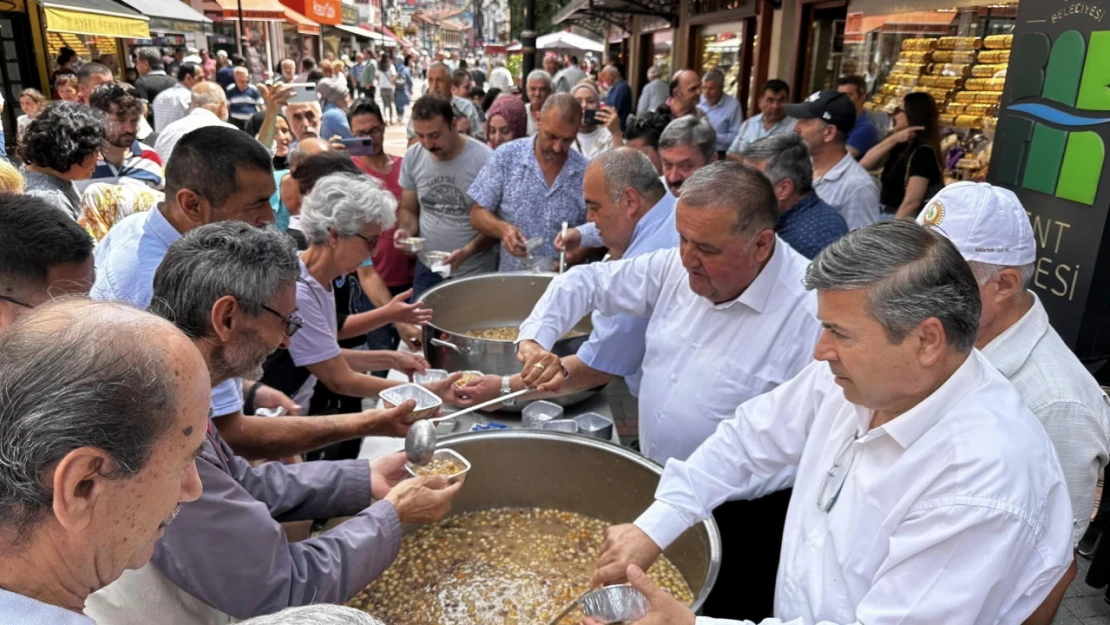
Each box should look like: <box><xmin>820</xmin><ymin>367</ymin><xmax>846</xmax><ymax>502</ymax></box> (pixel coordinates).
<box><xmin>918</xmin><ymin>182</ymin><xmax>1110</xmax><ymax>621</ymax></box>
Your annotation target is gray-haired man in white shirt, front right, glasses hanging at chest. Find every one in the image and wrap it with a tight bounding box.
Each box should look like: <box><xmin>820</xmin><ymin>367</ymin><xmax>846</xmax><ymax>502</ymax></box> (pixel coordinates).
<box><xmin>594</xmin><ymin>221</ymin><xmax>1072</xmax><ymax>625</ymax></box>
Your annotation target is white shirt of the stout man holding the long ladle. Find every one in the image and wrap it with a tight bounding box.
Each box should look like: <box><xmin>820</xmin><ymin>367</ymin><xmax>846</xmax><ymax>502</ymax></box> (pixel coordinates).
<box><xmin>519</xmin><ymin>240</ymin><xmax>821</xmax><ymax>464</ymax></box>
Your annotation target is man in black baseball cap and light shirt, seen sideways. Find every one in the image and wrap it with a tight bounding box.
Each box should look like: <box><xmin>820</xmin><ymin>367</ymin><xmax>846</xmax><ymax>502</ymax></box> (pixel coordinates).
<box><xmin>785</xmin><ymin>89</ymin><xmax>879</xmax><ymax>230</ymax></box>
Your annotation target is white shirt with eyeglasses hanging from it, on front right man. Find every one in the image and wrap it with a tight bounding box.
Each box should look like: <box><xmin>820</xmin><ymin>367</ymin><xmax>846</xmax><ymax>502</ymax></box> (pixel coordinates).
<box><xmin>636</xmin><ymin>351</ymin><xmax>1071</xmax><ymax>625</ymax></box>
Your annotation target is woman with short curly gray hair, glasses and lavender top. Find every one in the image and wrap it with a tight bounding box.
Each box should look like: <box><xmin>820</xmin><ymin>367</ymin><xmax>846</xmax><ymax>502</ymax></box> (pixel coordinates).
<box><xmin>266</xmin><ymin>173</ymin><xmax>457</xmax><ymax>415</ymax></box>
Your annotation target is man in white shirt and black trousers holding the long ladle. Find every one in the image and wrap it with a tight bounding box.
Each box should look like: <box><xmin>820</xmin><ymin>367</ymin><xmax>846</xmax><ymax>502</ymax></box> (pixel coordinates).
<box><xmin>518</xmin><ymin>163</ymin><xmax>820</xmax><ymax>614</ymax></box>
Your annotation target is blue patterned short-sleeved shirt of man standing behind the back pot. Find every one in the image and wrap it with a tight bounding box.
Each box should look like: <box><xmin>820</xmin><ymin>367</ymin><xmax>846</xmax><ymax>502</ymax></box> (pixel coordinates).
<box><xmin>470</xmin><ymin>137</ymin><xmax>589</xmax><ymax>272</ymax></box>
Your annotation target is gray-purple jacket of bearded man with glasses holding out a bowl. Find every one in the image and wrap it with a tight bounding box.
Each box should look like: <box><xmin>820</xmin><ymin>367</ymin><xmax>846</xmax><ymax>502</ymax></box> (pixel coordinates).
<box><xmin>87</xmin><ymin>427</ymin><xmax>401</xmax><ymax>625</ymax></box>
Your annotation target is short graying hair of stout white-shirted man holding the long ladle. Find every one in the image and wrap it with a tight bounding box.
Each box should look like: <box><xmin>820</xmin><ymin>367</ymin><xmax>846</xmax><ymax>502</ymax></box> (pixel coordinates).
<box><xmin>679</xmin><ymin>161</ymin><xmax>778</xmax><ymax>236</ymax></box>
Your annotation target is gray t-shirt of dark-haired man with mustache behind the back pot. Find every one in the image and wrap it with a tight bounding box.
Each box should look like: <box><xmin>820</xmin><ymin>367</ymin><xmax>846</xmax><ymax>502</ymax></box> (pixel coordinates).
<box><xmin>401</xmin><ymin>138</ymin><xmax>497</xmax><ymax>278</ymax></box>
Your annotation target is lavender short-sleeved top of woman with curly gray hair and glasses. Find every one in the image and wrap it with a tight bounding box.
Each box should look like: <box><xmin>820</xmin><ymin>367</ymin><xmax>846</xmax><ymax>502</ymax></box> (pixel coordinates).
<box><xmin>289</xmin><ymin>261</ymin><xmax>340</xmax><ymax>406</ymax></box>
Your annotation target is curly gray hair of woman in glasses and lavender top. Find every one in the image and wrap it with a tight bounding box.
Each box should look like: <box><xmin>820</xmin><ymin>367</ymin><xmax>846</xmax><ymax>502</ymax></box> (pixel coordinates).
<box><xmin>301</xmin><ymin>173</ymin><xmax>397</xmax><ymax>245</ymax></box>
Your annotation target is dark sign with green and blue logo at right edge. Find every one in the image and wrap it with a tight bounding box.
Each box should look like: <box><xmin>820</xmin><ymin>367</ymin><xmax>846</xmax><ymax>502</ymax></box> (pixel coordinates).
<box><xmin>989</xmin><ymin>0</ymin><xmax>1110</xmax><ymax>359</ymax></box>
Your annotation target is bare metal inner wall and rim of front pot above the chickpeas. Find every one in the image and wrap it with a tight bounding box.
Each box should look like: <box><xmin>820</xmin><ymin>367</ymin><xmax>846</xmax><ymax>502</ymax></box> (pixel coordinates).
<box><xmin>438</xmin><ymin>430</ymin><xmax>720</xmax><ymax>611</ymax></box>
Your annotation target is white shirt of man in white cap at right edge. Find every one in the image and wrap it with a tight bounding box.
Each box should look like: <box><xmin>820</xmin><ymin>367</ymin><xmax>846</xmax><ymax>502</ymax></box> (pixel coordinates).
<box><xmin>982</xmin><ymin>291</ymin><xmax>1110</xmax><ymax>544</ymax></box>
